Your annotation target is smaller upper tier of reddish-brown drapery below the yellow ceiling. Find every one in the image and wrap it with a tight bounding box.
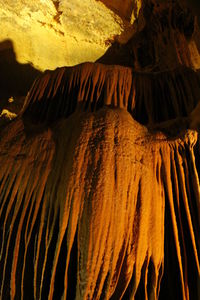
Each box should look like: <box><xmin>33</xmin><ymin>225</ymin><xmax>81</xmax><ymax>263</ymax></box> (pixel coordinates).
<box><xmin>23</xmin><ymin>63</ymin><xmax>200</xmax><ymax>124</ymax></box>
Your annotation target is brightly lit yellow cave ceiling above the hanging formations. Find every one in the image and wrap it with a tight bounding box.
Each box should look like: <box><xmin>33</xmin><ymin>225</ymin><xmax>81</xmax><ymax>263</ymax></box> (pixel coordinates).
<box><xmin>0</xmin><ymin>0</ymin><xmax>127</xmax><ymax>70</ymax></box>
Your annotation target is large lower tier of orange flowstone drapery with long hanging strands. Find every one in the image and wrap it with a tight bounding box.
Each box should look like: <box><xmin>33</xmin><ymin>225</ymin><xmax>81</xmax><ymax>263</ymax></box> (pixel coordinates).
<box><xmin>0</xmin><ymin>107</ymin><xmax>199</xmax><ymax>299</ymax></box>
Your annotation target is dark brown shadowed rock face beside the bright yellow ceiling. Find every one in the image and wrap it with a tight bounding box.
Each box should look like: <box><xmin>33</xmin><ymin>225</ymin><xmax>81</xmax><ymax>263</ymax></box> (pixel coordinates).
<box><xmin>98</xmin><ymin>1</ymin><xmax>200</xmax><ymax>72</ymax></box>
